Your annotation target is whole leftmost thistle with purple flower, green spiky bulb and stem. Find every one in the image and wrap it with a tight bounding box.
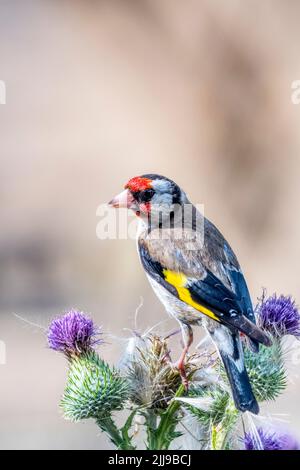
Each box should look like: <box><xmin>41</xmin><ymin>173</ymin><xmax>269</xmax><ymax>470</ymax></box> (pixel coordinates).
<box><xmin>48</xmin><ymin>310</ymin><xmax>133</xmax><ymax>449</ymax></box>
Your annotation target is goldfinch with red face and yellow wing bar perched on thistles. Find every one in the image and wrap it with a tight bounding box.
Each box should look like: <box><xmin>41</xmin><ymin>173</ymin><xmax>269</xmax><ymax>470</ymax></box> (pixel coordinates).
<box><xmin>109</xmin><ymin>173</ymin><xmax>271</xmax><ymax>414</ymax></box>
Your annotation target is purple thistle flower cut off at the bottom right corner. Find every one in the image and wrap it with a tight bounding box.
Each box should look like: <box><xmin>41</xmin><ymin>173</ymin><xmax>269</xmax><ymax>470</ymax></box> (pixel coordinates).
<box><xmin>244</xmin><ymin>428</ymin><xmax>300</xmax><ymax>450</ymax></box>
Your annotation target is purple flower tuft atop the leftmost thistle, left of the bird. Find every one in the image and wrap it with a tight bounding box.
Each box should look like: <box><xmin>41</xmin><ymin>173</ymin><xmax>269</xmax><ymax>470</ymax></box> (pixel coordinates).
<box><xmin>48</xmin><ymin>310</ymin><xmax>102</xmax><ymax>357</ymax></box>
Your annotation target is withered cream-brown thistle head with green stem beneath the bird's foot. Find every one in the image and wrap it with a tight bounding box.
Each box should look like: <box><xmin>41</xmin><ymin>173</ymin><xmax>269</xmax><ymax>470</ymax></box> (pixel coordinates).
<box><xmin>127</xmin><ymin>335</ymin><xmax>204</xmax><ymax>450</ymax></box>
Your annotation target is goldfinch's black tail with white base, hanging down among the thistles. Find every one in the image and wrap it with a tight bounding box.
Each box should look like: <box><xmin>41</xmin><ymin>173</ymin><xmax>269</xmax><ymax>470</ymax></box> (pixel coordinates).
<box><xmin>211</xmin><ymin>326</ymin><xmax>259</xmax><ymax>414</ymax></box>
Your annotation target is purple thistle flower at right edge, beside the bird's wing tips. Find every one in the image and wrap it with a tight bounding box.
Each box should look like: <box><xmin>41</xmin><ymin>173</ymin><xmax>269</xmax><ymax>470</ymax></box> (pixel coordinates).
<box><xmin>258</xmin><ymin>294</ymin><xmax>300</xmax><ymax>338</ymax></box>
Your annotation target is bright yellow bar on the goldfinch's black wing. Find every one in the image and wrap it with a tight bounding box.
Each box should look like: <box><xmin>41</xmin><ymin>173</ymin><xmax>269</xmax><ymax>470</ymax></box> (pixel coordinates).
<box><xmin>163</xmin><ymin>269</ymin><xmax>219</xmax><ymax>321</ymax></box>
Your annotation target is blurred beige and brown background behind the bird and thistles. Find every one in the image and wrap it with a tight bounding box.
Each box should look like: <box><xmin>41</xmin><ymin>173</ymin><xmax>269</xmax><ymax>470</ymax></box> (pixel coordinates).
<box><xmin>0</xmin><ymin>0</ymin><xmax>300</xmax><ymax>448</ymax></box>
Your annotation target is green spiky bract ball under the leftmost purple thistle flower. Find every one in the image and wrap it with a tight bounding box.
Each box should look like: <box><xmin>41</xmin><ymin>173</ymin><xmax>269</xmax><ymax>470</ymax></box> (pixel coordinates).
<box><xmin>61</xmin><ymin>351</ymin><xmax>128</xmax><ymax>421</ymax></box>
